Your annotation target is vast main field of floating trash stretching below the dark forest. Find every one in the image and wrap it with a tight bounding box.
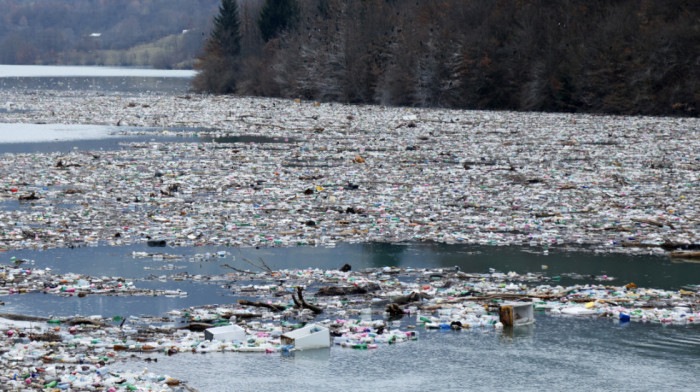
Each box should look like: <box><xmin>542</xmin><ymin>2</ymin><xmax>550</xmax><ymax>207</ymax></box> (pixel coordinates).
<box><xmin>0</xmin><ymin>91</ymin><xmax>700</xmax><ymax>254</ymax></box>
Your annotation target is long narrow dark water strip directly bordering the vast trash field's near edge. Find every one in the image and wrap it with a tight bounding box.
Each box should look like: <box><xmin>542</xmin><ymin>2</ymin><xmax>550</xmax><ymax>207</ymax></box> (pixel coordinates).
<box><xmin>0</xmin><ymin>243</ymin><xmax>700</xmax><ymax>290</ymax></box>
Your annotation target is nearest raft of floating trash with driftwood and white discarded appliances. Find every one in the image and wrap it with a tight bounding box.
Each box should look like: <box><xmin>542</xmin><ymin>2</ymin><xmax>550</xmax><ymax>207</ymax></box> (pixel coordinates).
<box><xmin>0</xmin><ymin>267</ymin><xmax>700</xmax><ymax>391</ymax></box>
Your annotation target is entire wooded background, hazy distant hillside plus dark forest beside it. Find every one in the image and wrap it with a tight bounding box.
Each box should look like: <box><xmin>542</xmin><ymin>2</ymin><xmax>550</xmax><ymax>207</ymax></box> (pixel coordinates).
<box><xmin>0</xmin><ymin>0</ymin><xmax>700</xmax><ymax>116</ymax></box>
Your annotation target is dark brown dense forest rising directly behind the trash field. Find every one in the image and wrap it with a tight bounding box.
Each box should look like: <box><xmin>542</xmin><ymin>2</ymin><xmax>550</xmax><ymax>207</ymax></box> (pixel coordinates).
<box><xmin>194</xmin><ymin>0</ymin><xmax>700</xmax><ymax>116</ymax></box>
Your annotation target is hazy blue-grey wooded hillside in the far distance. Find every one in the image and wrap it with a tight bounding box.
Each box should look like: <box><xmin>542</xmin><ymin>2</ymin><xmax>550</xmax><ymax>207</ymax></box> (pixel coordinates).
<box><xmin>0</xmin><ymin>0</ymin><xmax>220</xmax><ymax>67</ymax></box>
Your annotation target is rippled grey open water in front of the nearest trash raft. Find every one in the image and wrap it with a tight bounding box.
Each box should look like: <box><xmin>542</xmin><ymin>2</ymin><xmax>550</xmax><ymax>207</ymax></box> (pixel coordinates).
<box><xmin>117</xmin><ymin>315</ymin><xmax>700</xmax><ymax>392</ymax></box>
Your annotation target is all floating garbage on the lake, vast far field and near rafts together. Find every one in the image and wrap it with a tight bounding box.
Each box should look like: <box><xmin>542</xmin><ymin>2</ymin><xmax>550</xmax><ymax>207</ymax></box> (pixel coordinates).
<box><xmin>0</xmin><ymin>91</ymin><xmax>700</xmax><ymax>390</ymax></box>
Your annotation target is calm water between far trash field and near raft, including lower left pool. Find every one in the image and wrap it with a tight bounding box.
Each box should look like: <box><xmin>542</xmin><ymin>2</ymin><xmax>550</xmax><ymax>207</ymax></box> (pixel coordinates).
<box><xmin>0</xmin><ymin>243</ymin><xmax>700</xmax><ymax>316</ymax></box>
